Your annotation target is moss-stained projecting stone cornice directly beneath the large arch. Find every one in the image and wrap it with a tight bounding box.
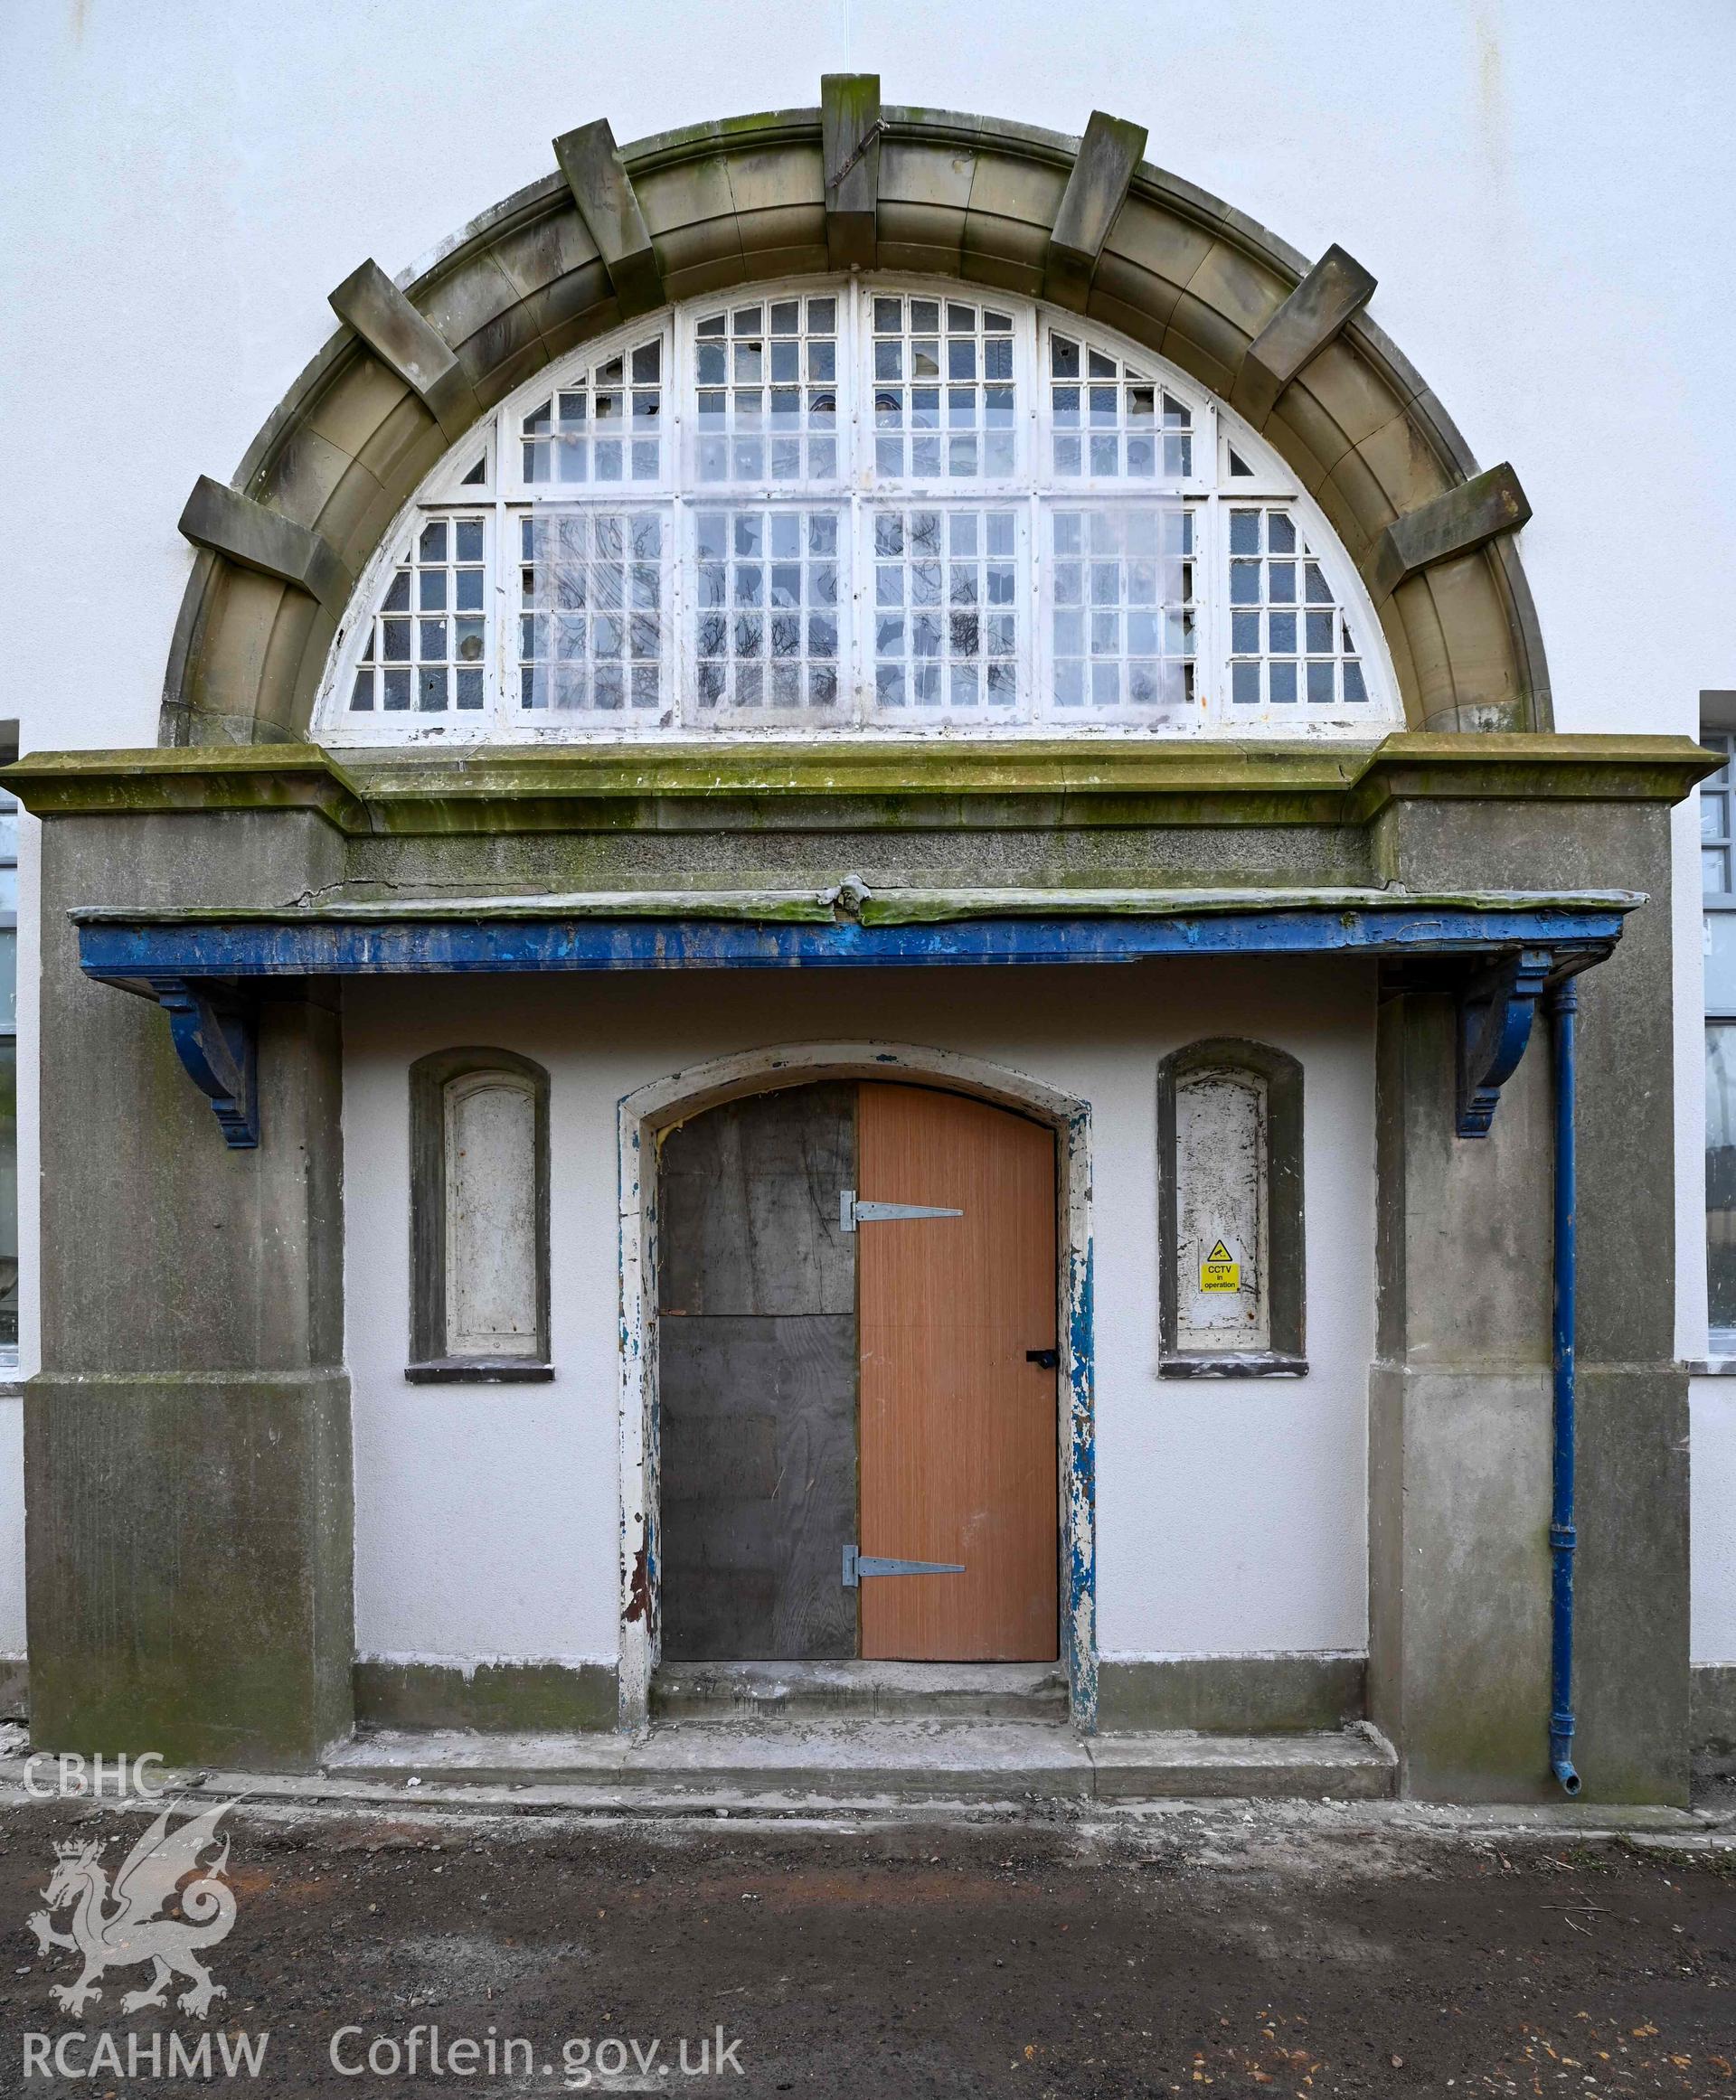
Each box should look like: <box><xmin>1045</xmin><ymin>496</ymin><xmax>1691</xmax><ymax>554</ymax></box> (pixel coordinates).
<box><xmin>0</xmin><ymin>730</ymin><xmax>1722</xmax><ymax>836</ymax></box>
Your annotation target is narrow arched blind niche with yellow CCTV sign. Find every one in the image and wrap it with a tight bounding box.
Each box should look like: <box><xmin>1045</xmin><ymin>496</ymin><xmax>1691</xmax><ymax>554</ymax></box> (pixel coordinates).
<box><xmin>1159</xmin><ymin>1038</ymin><xmax>1307</xmax><ymax>1378</ymax></box>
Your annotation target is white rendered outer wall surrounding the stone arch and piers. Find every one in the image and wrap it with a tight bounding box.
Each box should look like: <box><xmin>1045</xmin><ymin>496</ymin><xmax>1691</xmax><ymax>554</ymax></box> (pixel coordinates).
<box><xmin>0</xmin><ymin>0</ymin><xmax>1736</xmax><ymax>1659</ymax></box>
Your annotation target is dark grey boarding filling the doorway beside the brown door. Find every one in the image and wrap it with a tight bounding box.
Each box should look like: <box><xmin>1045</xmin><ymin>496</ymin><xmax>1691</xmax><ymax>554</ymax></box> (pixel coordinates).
<box><xmin>659</xmin><ymin>1084</ymin><xmax>856</xmax><ymax>1661</ymax></box>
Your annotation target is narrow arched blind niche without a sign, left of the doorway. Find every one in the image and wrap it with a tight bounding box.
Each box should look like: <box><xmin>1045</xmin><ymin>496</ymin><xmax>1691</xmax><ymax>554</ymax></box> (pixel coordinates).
<box><xmin>405</xmin><ymin>1050</ymin><xmax>552</xmax><ymax>1384</ymax></box>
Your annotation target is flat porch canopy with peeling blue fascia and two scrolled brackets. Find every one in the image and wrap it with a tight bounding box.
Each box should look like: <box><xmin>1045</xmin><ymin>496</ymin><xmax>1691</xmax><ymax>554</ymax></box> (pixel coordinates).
<box><xmin>71</xmin><ymin>878</ymin><xmax>1644</xmax><ymax>1146</ymax></box>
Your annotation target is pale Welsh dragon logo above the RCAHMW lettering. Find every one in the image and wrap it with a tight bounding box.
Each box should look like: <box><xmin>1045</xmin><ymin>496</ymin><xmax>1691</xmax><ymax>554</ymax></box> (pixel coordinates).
<box><xmin>27</xmin><ymin>1802</ymin><xmax>235</xmax><ymax>2020</ymax></box>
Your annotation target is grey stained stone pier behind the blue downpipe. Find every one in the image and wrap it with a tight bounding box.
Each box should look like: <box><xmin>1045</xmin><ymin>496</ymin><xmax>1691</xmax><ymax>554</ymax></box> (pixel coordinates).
<box><xmin>1369</xmin><ymin>796</ymin><xmax>1690</xmax><ymax>1802</ymax></box>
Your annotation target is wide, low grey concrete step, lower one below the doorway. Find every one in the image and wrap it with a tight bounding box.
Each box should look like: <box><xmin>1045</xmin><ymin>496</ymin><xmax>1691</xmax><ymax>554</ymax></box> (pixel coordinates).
<box><xmin>326</xmin><ymin>1720</ymin><xmax>1396</xmax><ymax>1808</ymax></box>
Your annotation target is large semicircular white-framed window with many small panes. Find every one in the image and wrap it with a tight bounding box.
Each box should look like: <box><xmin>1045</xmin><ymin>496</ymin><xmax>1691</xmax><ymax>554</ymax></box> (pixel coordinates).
<box><xmin>319</xmin><ymin>279</ymin><xmax>1402</xmax><ymax>743</ymax></box>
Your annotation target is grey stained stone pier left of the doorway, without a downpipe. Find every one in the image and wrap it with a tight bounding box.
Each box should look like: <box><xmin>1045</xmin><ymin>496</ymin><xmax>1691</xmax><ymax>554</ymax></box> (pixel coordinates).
<box><xmin>25</xmin><ymin>811</ymin><xmax>354</xmax><ymax>1768</ymax></box>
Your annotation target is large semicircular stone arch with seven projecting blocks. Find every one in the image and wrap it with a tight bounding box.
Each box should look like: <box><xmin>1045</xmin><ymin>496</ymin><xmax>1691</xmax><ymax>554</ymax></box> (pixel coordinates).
<box><xmin>159</xmin><ymin>88</ymin><xmax>1553</xmax><ymax>743</ymax></box>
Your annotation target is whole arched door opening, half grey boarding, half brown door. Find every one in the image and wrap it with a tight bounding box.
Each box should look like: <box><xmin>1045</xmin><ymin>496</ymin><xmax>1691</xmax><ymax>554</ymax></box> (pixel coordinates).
<box><xmin>657</xmin><ymin>1079</ymin><xmax>1060</xmax><ymax>1661</ymax></box>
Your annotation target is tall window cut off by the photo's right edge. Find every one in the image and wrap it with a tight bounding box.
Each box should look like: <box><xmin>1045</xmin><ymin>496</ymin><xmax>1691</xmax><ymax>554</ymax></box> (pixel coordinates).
<box><xmin>1701</xmin><ymin>729</ymin><xmax>1736</xmax><ymax>1357</ymax></box>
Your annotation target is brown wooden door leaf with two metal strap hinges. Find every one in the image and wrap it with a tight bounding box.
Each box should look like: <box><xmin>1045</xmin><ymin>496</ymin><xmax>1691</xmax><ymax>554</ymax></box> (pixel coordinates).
<box><xmin>856</xmin><ymin>1084</ymin><xmax>1058</xmax><ymax>1661</ymax></box>
